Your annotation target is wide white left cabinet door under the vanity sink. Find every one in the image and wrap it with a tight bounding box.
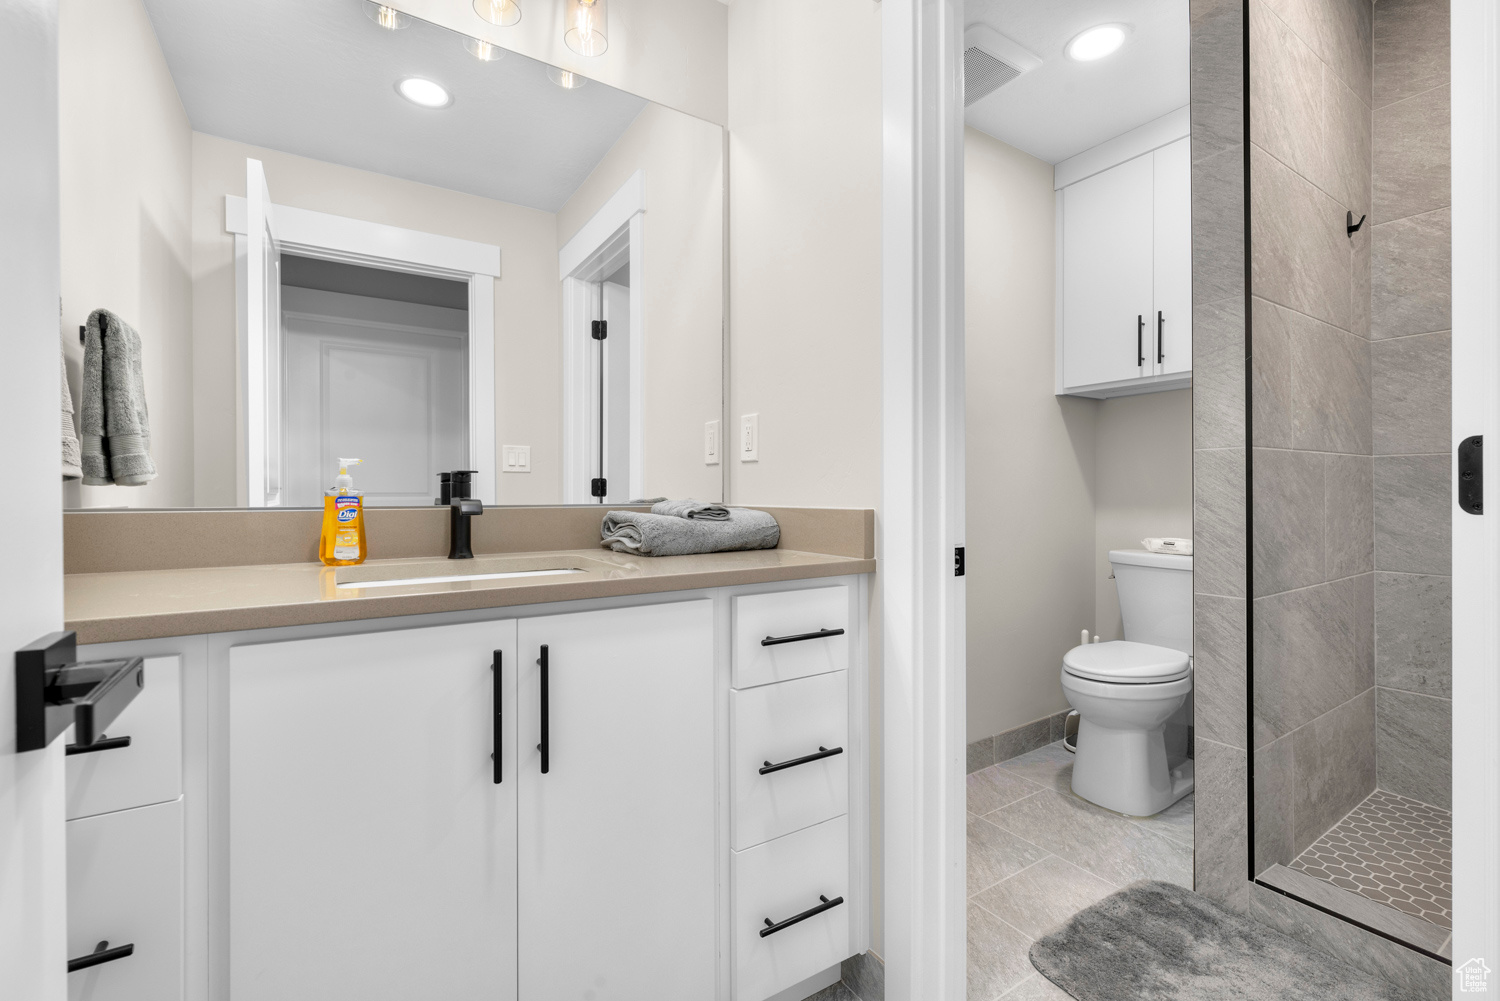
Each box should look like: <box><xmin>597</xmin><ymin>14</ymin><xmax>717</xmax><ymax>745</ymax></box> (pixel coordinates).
<box><xmin>228</xmin><ymin>621</ymin><xmax>516</xmax><ymax>1001</ymax></box>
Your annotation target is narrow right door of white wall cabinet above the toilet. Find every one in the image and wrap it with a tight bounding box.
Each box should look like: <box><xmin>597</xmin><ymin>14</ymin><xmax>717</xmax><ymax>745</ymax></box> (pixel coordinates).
<box><xmin>1148</xmin><ymin>140</ymin><xmax>1193</xmax><ymax>375</ymax></box>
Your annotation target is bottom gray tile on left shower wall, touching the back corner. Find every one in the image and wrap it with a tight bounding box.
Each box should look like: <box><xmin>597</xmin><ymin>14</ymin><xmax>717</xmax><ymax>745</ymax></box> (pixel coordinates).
<box><xmin>1292</xmin><ymin>687</ymin><xmax>1376</xmax><ymax>854</ymax></box>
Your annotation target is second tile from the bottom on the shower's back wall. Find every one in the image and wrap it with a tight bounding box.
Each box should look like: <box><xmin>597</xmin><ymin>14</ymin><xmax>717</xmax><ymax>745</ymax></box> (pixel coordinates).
<box><xmin>1376</xmin><ymin>573</ymin><xmax>1454</xmax><ymax>698</ymax></box>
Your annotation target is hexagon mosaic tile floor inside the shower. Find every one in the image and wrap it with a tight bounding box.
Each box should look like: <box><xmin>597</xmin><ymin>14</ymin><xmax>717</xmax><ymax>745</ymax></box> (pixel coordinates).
<box><xmin>1292</xmin><ymin>789</ymin><xmax>1454</xmax><ymax>929</ymax></box>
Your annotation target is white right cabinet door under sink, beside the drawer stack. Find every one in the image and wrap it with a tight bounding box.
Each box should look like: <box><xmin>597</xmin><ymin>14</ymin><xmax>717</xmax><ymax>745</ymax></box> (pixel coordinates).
<box><xmin>519</xmin><ymin>599</ymin><xmax>719</xmax><ymax>1001</ymax></box>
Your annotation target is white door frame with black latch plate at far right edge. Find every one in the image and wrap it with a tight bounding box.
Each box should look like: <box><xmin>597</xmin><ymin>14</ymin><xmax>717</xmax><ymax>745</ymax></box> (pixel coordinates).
<box><xmin>1451</xmin><ymin>0</ymin><xmax>1500</xmax><ymax>998</ymax></box>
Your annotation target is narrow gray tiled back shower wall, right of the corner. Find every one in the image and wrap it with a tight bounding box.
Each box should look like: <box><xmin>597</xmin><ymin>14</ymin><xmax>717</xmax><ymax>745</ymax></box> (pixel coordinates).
<box><xmin>1370</xmin><ymin>0</ymin><xmax>1454</xmax><ymax>809</ymax></box>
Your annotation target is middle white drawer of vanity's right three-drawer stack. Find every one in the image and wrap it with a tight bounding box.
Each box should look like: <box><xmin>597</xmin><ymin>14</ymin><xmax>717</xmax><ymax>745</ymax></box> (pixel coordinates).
<box><xmin>729</xmin><ymin>671</ymin><xmax>851</xmax><ymax>851</ymax></box>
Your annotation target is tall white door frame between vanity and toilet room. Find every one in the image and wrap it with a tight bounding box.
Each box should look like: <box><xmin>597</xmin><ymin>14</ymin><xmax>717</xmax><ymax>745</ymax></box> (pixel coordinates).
<box><xmin>879</xmin><ymin>0</ymin><xmax>968</xmax><ymax>1001</ymax></box>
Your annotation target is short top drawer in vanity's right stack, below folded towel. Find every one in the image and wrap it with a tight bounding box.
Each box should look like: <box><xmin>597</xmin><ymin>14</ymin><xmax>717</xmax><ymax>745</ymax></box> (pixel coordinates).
<box><xmin>734</xmin><ymin>584</ymin><xmax>849</xmax><ymax>689</ymax></box>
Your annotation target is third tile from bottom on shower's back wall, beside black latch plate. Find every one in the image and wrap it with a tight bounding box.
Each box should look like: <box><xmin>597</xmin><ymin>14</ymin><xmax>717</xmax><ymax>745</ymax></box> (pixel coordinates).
<box><xmin>1374</xmin><ymin>453</ymin><xmax>1452</xmax><ymax>576</ymax></box>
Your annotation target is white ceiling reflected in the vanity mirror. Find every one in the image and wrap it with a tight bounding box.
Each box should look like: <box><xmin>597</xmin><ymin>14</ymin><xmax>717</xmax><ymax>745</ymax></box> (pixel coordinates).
<box><xmin>144</xmin><ymin>0</ymin><xmax>647</xmax><ymax>212</ymax></box>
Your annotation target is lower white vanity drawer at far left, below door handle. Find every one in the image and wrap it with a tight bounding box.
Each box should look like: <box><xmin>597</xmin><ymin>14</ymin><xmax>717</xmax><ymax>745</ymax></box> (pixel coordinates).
<box><xmin>66</xmin><ymin>800</ymin><xmax>183</xmax><ymax>1001</ymax></box>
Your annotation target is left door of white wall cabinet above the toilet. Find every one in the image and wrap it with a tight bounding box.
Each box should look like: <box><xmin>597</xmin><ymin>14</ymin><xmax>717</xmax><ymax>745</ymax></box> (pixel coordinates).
<box><xmin>1062</xmin><ymin>155</ymin><xmax>1154</xmax><ymax>389</ymax></box>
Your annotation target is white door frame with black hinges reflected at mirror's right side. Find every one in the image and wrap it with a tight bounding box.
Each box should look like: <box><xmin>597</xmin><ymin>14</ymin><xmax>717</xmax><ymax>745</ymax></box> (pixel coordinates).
<box><xmin>558</xmin><ymin>170</ymin><xmax>647</xmax><ymax>504</ymax></box>
